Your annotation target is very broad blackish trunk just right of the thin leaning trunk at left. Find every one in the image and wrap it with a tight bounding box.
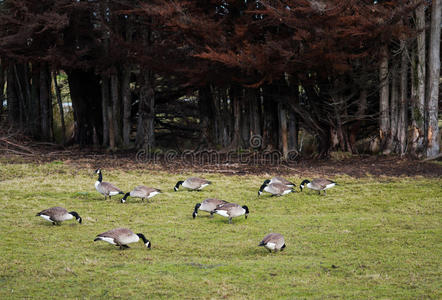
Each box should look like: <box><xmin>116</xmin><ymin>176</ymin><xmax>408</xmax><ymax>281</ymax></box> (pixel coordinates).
<box><xmin>67</xmin><ymin>69</ymin><xmax>102</xmax><ymax>145</ymax></box>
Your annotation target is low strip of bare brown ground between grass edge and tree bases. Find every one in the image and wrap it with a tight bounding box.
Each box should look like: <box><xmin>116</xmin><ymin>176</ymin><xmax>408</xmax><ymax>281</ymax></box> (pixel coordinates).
<box><xmin>0</xmin><ymin>145</ymin><xmax>442</xmax><ymax>178</ymax></box>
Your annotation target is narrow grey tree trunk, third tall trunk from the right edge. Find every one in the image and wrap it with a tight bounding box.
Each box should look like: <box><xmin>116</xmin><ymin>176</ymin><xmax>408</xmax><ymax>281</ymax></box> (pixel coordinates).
<box><xmin>397</xmin><ymin>40</ymin><xmax>408</xmax><ymax>156</ymax></box>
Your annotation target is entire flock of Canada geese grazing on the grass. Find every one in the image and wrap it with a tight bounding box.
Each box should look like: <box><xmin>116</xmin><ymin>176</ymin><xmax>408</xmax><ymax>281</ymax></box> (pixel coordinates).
<box><xmin>37</xmin><ymin>169</ymin><xmax>337</xmax><ymax>252</ymax></box>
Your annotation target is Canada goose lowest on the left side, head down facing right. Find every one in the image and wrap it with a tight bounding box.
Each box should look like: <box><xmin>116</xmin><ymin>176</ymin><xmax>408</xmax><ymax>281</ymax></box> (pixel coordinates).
<box><xmin>94</xmin><ymin>228</ymin><xmax>151</xmax><ymax>249</ymax></box>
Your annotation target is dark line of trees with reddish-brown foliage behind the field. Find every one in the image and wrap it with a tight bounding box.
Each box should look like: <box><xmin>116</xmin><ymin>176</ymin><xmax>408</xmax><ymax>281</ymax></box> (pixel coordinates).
<box><xmin>0</xmin><ymin>0</ymin><xmax>441</xmax><ymax>157</ymax></box>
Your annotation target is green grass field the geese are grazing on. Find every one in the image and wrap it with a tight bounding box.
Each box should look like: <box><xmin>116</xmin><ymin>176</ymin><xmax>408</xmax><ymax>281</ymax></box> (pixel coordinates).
<box><xmin>0</xmin><ymin>162</ymin><xmax>442</xmax><ymax>299</ymax></box>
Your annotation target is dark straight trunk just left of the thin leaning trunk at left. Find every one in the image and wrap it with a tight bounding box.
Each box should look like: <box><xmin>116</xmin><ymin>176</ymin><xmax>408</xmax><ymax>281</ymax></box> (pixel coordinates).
<box><xmin>40</xmin><ymin>64</ymin><xmax>51</xmax><ymax>141</ymax></box>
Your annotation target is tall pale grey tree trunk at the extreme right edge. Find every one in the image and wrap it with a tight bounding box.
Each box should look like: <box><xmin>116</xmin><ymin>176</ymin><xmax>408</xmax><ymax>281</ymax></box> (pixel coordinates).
<box><xmin>426</xmin><ymin>0</ymin><xmax>442</xmax><ymax>157</ymax></box>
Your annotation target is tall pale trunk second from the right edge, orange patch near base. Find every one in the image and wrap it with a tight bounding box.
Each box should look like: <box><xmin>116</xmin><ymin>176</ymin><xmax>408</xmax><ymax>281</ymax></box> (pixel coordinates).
<box><xmin>411</xmin><ymin>0</ymin><xmax>426</xmax><ymax>155</ymax></box>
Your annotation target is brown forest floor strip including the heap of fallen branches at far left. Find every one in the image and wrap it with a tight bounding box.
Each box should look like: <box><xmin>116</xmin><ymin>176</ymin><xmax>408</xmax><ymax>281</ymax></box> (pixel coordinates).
<box><xmin>0</xmin><ymin>130</ymin><xmax>442</xmax><ymax>178</ymax></box>
